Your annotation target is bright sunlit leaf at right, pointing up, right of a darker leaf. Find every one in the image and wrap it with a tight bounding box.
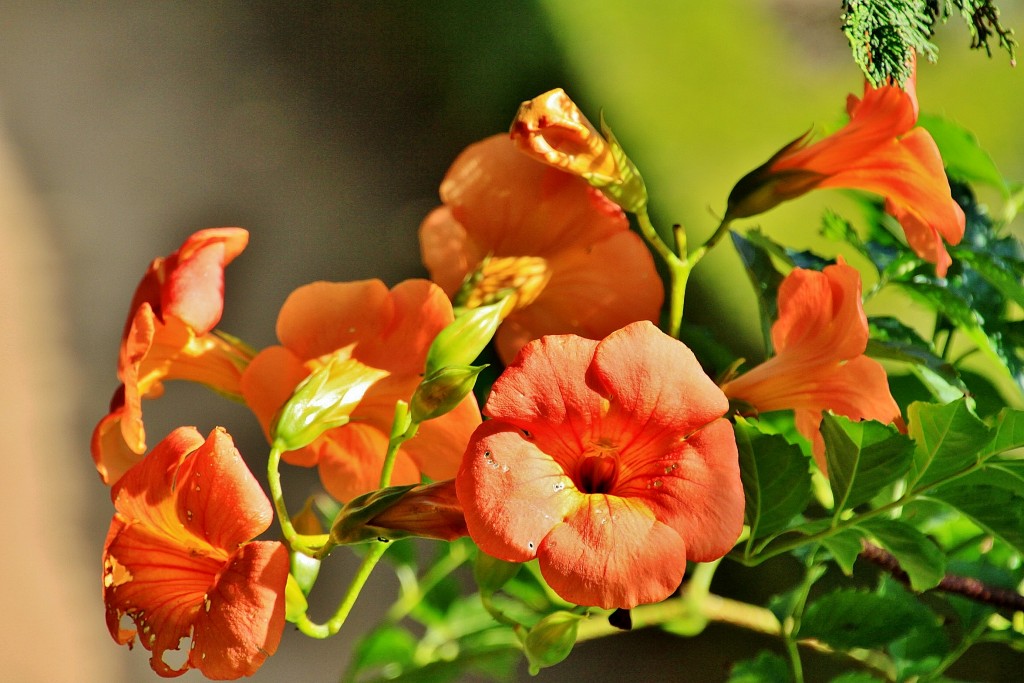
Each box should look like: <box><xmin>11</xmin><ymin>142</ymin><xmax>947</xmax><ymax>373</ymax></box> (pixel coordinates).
<box><xmin>907</xmin><ymin>399</ymin><xmax>990</xmax><ymax>487</ymax></box>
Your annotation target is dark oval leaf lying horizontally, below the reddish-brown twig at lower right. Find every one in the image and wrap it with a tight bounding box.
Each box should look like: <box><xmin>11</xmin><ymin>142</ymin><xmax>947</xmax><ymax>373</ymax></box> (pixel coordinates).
<box><xmin>798</xmin><ymin>589</ymin><xmax>937</xmax><ymax>649</ymax></box>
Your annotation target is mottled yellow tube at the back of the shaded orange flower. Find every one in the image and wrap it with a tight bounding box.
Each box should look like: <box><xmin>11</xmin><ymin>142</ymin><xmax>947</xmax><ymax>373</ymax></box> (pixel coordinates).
<box><xmin>455</xmin><ymin>256</ymin><xmax>551</xmax><ymax>310</ymax></box>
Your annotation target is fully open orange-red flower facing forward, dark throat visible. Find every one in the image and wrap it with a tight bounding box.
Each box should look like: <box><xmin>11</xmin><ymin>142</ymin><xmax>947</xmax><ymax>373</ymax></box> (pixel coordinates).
<box><xmin>456</xmin><ymin>322</ymin><xmax>743</xmax><ymax>608</ymax></box>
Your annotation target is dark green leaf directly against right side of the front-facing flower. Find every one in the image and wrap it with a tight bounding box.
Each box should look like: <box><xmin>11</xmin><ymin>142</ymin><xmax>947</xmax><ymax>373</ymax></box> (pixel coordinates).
<box><xmin>735</xmin><ymin>418</ymin><xmax>811</xmax><ymax>539</ymax></box>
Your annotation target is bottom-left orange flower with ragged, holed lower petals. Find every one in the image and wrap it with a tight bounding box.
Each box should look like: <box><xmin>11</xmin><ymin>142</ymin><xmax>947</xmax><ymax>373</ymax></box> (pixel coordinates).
<box><xmin>103</xmin><ymin>427</ymin><xmax>288</xmax><ymax>679</ymax></box>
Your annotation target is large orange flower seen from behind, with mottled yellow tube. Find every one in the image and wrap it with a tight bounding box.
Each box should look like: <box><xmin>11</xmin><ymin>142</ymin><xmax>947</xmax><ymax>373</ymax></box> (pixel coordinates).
<box><xmin>420</xmin><ymin>135</ymin><xmax>664</xmax><ymax>364</ymax></box>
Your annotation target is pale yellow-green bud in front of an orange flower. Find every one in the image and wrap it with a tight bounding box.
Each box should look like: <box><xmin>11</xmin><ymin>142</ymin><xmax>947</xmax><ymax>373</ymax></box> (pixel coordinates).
<box><xmin>270</xmin><ymin>355</ymin><xmax>388</xmax><ymax>451</ymax></box>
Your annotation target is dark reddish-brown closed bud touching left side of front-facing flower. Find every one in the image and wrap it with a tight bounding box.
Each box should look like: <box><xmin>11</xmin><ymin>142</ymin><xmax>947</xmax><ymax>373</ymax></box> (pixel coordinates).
<box><xmin>331</xmin><ymin>479</ymin><xmax>468</xmax><ymax>545</ymax></box>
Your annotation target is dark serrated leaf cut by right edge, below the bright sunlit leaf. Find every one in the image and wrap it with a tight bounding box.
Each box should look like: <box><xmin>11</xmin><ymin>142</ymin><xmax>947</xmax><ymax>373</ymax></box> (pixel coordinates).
<box><xmin>929</xmin><ymin>481</ymin><xmax>1024</xmax><ymax>553</ymax></box>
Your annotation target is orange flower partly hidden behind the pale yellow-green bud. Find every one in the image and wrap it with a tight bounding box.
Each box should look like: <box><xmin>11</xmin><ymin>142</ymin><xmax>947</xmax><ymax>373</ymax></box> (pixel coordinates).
<box><xmin>242</xmin><ymin>280</ymin><xmax>480</xmax><ymax>501</ymax></box>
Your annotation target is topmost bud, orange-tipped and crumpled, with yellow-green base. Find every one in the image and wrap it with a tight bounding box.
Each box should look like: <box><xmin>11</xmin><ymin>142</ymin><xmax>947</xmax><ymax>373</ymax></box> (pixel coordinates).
<box><xmin>511</xmin><ymin>88</ymin><xmax>647</xmax><ymax>212</ymax></box>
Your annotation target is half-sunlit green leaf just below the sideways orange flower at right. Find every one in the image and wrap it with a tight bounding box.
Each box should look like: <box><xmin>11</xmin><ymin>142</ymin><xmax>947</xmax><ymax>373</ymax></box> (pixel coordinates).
<box><xmin>821</xmin><ymin>413</ymin><xmax>913</xmax><ymax>514</ymax></box>
